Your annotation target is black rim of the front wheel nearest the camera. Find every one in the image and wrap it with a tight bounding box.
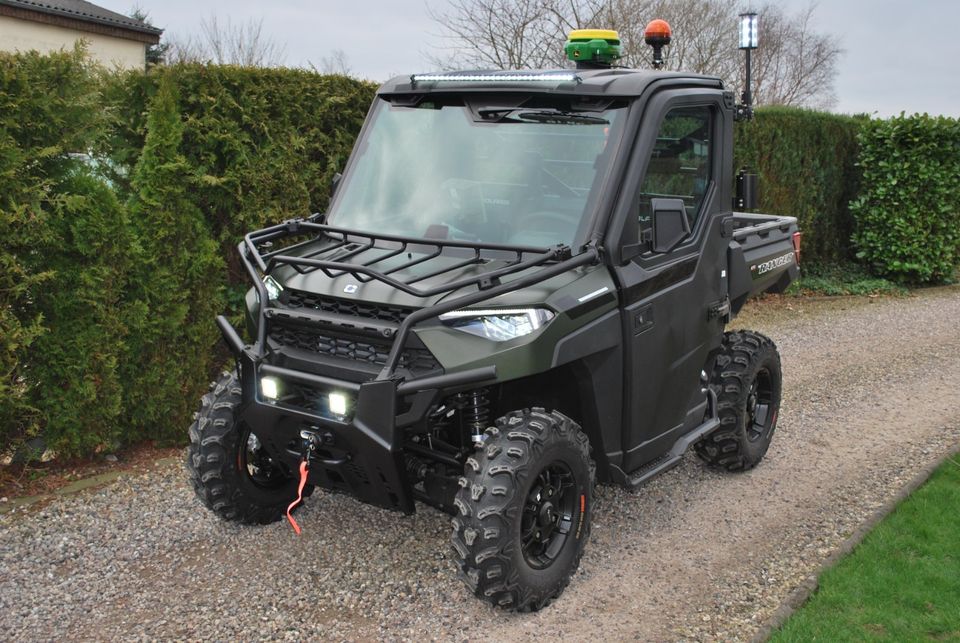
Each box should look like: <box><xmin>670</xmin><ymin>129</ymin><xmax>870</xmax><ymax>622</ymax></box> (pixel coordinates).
<box><xmin>520</xmin><ymin>461</ymin><xmax>577</xmax><ymax>569</ymax></box>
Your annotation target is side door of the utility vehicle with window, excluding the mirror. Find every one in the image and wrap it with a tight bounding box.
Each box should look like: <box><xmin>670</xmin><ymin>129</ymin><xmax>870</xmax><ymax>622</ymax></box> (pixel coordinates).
<box><xmin>615</xmin><ymin>89</ymin><xmax>729</xmax><ymax>472</ymax></box>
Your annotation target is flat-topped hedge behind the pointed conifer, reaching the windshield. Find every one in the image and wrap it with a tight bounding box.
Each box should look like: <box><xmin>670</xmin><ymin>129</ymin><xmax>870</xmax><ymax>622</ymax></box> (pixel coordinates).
<box><xmin>101</xmin><ymin>65</ymin><xmax>376</xmax><ymax>284</ymax></box>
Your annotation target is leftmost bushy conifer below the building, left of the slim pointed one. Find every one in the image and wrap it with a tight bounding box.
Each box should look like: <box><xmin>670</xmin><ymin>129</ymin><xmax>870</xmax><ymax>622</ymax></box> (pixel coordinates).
<box><xmin>0</xmin><ymin>50</ymin><xmax>132</xmax><ymax>453</ymax></box>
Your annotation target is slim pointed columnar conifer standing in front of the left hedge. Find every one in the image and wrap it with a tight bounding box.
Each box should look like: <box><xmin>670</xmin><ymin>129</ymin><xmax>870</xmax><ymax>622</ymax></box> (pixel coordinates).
<box><xmin>119</xmin><ymin>76</ymin><xmax>224</xmax><ymax>437</ymax></box>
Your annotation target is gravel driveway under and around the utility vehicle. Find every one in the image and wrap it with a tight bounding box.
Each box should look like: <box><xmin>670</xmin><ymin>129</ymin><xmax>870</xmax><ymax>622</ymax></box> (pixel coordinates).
<box><xmin>0</xmin><ymin>288</ymin><xmax>960</xmax><ymax>640</ymax></box>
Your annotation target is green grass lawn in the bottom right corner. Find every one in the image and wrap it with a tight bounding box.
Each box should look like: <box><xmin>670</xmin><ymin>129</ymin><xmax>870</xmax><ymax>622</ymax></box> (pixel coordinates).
<box><xmin>771</xmin><ymin>457</ymin><xmax>960</xmax><ymax>643</ymax></box>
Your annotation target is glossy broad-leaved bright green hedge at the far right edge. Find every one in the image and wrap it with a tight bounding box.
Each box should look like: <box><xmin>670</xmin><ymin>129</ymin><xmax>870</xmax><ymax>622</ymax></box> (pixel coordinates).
<box><xmin>851</xmin><ymin>115</ymin><xmax>960</xmax><ymax>283</ymax></box>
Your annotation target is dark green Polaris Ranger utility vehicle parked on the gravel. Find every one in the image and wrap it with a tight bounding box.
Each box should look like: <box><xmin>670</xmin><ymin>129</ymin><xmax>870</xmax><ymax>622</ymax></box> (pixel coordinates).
<box><xmin>188</xmin><ymin>20</ymin><xmax>799</xmax><ymax>610</ymax></box>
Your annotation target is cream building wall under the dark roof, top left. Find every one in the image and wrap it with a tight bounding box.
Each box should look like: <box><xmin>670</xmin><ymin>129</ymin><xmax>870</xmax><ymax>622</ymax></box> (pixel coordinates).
<box><xmin>0</xmin><ymin>16</ymin><xmax>147</xmax><ymax>69</ymax></box>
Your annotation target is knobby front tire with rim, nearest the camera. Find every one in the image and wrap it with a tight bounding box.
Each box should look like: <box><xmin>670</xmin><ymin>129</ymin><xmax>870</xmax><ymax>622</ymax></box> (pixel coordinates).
<box><xmin>453</xmin><ymin>408</ymin><xmax>595</xmax><ymax>611</ymax></box>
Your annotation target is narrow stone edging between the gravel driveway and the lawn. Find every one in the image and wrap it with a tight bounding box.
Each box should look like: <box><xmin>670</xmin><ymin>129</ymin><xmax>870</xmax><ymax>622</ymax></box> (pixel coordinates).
<box><xmin>750</xmin><ymin>444</ymin><xmax>960</xmax><ymax>643</ymax></box>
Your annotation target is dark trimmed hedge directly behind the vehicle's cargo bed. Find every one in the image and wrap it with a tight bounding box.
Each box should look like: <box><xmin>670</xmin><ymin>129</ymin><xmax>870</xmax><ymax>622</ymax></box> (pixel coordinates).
<box><xmin>734</xmin><ymin>107</ymin><xmax>864</xmax><ymax>264</ymax></box>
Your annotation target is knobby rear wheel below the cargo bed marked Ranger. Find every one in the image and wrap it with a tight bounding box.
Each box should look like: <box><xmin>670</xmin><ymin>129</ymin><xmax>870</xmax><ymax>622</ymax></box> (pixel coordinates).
<box><xmin>695</xmin><ymin>330</ymin><xmax>782</xmax><ymax>471</ymax></box>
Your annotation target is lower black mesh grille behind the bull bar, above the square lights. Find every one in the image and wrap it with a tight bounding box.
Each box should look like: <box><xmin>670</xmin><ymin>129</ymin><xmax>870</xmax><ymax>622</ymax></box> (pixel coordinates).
<box><xmin>270</xmin><ymin>324</ymin><xmax>440</xmax><ymax>375</ymax></box>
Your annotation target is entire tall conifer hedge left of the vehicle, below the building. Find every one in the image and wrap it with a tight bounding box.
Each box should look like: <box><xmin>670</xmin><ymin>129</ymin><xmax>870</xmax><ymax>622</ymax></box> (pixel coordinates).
<box><xmin>0</xmin><ymin>51</ymin><xmax>375</xmax><ymax>455</ymax></box>
